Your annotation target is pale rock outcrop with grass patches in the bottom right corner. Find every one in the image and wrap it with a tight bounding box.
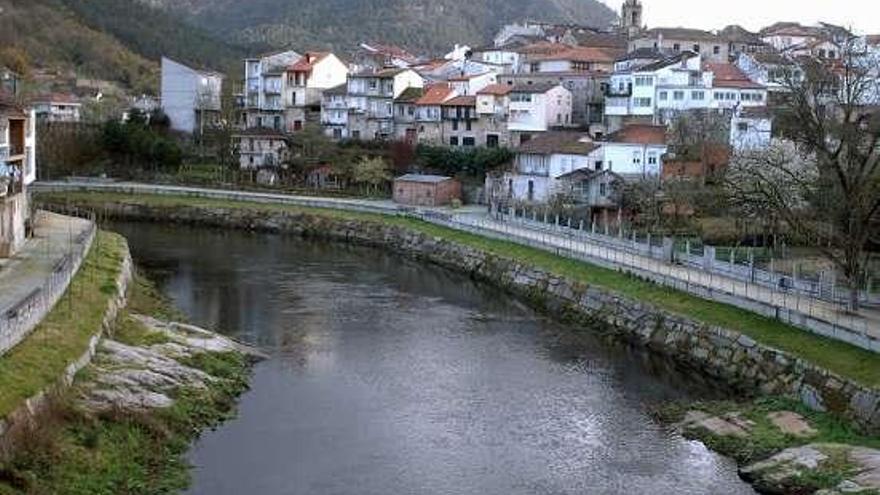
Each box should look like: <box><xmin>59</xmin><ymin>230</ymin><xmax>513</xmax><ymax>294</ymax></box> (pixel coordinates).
<box><xmin>740</xmin><ymin>444</ymin><xmax>880</xmax><ymax>495</ymax></box>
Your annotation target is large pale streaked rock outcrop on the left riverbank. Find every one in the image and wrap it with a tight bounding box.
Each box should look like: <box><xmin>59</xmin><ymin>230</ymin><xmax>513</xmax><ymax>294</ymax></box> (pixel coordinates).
<box><xmin>81</xmin><ymin>315</ymin><xmax>263</xmax><ymax>412</ymax></box>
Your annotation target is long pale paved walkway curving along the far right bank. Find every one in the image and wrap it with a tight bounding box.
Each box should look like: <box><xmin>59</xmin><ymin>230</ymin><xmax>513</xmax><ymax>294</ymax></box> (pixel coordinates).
<box><xmin>36</xmin><ymin>182</ymin><xmax>880</xmax><ymax>350</ymax></box>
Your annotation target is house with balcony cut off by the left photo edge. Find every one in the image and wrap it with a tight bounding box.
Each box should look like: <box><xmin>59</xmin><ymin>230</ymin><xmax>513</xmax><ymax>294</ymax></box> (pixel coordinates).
<box><xmin>0</xmin><ymin>98</ymin><xmax>37</xmax><ymax>258</ymax></box>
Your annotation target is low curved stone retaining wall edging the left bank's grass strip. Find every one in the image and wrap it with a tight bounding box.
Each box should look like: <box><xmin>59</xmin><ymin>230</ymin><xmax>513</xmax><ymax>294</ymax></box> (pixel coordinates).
<box><xmin>0</xmin><ymin>238</ymin><xmax>134</xmax><ymax>457</ymax></box>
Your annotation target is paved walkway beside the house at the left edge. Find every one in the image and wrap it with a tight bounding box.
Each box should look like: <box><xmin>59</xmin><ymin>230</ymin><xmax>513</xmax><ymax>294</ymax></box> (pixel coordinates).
<box><xmin>0</xmin><ymin>211</ymin><xmax>91</xmax><ymax>319</ymax></box>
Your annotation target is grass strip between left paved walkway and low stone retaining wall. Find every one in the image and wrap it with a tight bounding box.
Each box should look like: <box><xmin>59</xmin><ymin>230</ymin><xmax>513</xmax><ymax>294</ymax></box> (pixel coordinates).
<box><xmin>0</xmin><ymin>232</ymin><xmax>127</xmax><ymax>417</ymax></box>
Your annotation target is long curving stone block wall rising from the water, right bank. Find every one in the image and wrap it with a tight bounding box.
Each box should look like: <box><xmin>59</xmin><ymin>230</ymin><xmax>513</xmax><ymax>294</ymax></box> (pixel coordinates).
<box><xmin>39</xmin><ymin>203</ymin><xmax>880</xmax><ymax>433</ymax></box>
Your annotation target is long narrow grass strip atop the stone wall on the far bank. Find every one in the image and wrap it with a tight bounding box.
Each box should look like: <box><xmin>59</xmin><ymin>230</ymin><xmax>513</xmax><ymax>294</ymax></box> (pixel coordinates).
<box><xmin>38</xmin><ymin>192</ymin><xmax>880</xmax><ymax>387</ymax></box>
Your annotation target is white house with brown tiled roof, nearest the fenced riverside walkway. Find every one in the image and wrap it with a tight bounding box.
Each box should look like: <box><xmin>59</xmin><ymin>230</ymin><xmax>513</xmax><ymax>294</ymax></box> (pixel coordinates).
<box><xmin>502</xmin><ymin>131</ymin><xmax>602</xmax><ymax>203</ymax></box>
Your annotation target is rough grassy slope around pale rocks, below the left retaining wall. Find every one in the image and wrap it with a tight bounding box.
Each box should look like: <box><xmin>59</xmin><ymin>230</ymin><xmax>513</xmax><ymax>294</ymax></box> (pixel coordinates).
<box><xmin>0</xmin><ymin>277</ymin><xmax>249</xmax><ymax>495</ymax></box>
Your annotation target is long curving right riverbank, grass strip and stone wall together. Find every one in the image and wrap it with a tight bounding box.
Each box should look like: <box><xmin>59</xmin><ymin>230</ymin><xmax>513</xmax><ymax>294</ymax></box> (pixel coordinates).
<box><xmin>38</xmin><ymin>193</ymin><xmax>880</xmax><ymax>433</ymax></box>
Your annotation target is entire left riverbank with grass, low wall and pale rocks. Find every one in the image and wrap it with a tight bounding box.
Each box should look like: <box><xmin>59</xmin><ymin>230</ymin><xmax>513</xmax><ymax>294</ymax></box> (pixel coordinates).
<box><xmin>0</xmin><ymin>232</ymin><xmax>258</xmax><ymax>495</ymax></box>
